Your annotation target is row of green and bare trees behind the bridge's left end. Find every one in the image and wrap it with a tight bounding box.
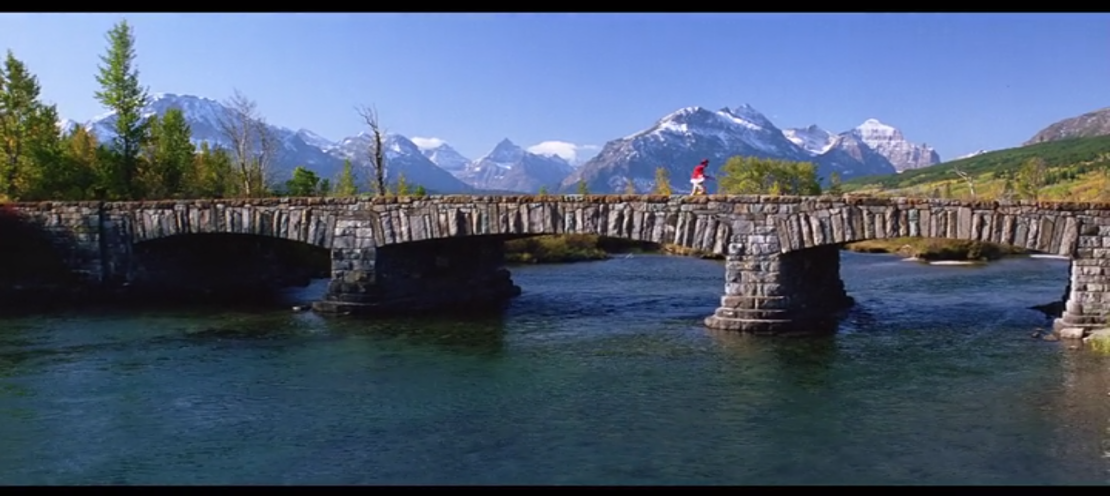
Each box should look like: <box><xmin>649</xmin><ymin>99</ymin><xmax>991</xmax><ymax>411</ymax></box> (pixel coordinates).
<box><xmin>0</xmin><ymin>20</ymin><xmax>408</xmax><ymax>201</ymax></box>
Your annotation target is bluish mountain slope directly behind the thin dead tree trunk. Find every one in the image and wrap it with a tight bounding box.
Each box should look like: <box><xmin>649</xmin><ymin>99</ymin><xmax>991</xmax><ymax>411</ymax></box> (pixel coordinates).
<box><xmin>327</xmin><ymin>132</ymin><xmax>474</xmax><ymax>193</ymax></box>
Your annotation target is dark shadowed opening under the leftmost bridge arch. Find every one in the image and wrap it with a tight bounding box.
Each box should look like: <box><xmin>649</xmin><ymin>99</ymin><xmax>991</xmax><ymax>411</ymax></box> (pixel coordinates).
<box><xmin>128</xmin><ymin>233</ymin><xmax>331</xmax><ymax>304</ymax></box>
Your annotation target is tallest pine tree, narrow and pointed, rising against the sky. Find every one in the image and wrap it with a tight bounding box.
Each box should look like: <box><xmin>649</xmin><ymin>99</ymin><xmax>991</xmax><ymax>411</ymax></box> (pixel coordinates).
<box><xmin>95</xmin><ymin>20</ymin><xmax>149</xmax><ymax>199</ymax></box>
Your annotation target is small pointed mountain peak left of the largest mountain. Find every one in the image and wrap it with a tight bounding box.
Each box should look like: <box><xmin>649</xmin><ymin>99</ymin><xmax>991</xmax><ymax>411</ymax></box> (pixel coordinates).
<box><xmin>456</xmin><ymin>139</ymin><xmax>574</xmax><ymax>193</ymax></box>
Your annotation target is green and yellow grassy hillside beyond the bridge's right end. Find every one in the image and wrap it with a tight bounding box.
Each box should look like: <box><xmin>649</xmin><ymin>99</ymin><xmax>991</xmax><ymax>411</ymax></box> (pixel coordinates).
<box><xmin>842</xmin><ymin>136</ymin><xmax>1110</xmax><ymax>201</ymax></box>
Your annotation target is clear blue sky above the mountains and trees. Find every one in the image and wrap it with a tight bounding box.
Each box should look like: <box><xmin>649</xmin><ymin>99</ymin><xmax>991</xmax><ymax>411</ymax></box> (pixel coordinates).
<box><xmin>0</xmin><ymin>13</ymin><xmax>1110</xmax><ymax>159</ymax></box>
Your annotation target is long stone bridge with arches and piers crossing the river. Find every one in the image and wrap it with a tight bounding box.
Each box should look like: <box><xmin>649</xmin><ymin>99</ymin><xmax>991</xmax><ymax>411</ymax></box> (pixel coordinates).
<box><xmin>0</xmin><ymin>195</ymin><xmax>1110</xmax><ymax>333</ymax></box>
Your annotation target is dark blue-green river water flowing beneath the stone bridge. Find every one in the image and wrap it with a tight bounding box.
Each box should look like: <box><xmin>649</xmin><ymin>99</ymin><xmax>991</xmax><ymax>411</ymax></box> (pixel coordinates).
<box><xmin>0</xmin><ymin>253</ymin><xmax>1110</xmax><ymax>484</ymax></box>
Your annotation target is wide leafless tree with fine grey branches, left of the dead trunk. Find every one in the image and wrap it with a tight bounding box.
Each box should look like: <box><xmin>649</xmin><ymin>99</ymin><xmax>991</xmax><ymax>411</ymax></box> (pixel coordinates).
<box><xmin>216</xmin><ymin>89</ymin><xmax>276</xmax><ymax>196</ymax></box>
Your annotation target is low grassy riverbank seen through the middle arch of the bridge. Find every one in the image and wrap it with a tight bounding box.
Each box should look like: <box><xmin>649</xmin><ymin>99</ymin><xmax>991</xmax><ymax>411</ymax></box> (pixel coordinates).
<box><xmin>505</xmin><ymin>234</ymin><xmax>724</xmax><ymax>264</ymax></box>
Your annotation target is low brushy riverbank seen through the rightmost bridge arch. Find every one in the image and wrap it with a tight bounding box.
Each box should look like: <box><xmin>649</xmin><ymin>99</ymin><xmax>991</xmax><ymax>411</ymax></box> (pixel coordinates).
<box><xmin>845</xmin><ymin>237</ymin><xmax>1029</xmax><ymax>262</ymax></box>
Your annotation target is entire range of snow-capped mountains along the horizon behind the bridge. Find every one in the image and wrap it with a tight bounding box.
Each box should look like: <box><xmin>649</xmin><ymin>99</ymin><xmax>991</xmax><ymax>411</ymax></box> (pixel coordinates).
<box><xmin>59</xmin><ymin>93</ymin><xmax>940</xmax><ymax>193</ymax></box>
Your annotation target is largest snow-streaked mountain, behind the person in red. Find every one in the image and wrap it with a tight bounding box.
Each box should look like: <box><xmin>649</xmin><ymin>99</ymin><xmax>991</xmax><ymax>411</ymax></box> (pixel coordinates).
<box><xmin>562</xmin><ymin>104</ymin><xmax>895</xmax><ymax>193</ymax></box>
